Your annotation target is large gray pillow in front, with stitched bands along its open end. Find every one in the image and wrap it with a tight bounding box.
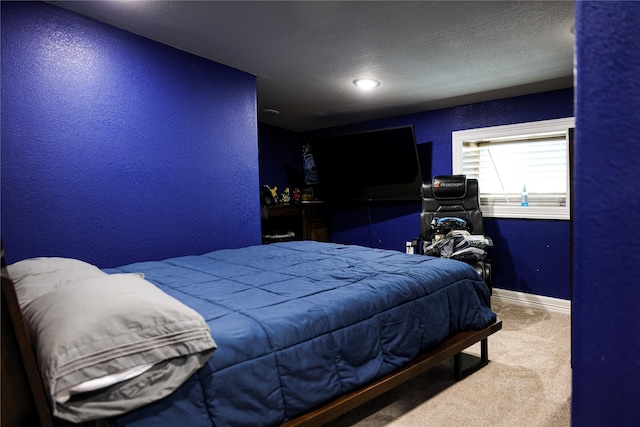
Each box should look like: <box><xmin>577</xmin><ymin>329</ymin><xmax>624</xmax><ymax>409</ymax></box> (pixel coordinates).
<box><xmin>16</xmin><ymin>274</ymin><xmax>216</xmax><ymax>422</ymax></box>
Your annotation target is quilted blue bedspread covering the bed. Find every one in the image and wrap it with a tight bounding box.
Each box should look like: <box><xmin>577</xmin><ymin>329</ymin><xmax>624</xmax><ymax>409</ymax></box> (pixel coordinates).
<box><xmin>105</xmin><ymin>241</ymin><xmax>495</xmax><ymax>427</ymax></box>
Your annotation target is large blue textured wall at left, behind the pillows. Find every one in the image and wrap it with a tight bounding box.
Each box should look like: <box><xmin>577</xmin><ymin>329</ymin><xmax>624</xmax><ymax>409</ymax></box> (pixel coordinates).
<box><xmin>1</xmin><ymin>2</ymin><xmax>260</xmax><ymax>267</ymax></box>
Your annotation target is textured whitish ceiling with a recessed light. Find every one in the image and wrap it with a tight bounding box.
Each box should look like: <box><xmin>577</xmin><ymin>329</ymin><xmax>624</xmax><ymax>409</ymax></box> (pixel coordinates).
<box><xmin>50</xmin><ymin>0</ymin><xmax>574</xmax><ymax>132</ymax></box>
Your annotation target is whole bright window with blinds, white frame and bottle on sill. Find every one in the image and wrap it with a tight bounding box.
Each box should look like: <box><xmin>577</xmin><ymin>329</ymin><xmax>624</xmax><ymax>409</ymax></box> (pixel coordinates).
<box><xmin>452</xmin><ymin>118</ymin><xmax>575</xmax><ymax>219</ymax></box>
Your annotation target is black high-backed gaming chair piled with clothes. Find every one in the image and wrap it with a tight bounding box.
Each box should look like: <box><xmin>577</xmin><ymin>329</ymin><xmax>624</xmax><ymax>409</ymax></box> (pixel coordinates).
<box><xmin>419</xmin><ymin>175</ymin><xmax>493</xmax><ymax>289</ymax></box>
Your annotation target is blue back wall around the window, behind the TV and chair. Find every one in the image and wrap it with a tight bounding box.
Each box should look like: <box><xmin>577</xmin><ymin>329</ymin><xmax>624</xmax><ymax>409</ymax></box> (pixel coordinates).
<box><xmin>305</xmin><ymin>88</ymin><xmax>574</xmax><ymax>300</ymax></box>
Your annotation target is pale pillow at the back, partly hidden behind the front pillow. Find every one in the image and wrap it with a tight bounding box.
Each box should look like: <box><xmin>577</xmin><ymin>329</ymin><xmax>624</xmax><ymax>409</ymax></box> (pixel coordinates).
<box><xmin>7</xmin><ymin>257</ymin><xmax>107</xmax><ymax>309</ymax></box>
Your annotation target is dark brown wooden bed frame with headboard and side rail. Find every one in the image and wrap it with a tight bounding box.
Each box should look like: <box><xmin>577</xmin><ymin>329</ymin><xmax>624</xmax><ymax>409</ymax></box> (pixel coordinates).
<box><xmin>1</xmin><ymin>265</ymin><xmax>502</xmax><ymax>427</ymax></box>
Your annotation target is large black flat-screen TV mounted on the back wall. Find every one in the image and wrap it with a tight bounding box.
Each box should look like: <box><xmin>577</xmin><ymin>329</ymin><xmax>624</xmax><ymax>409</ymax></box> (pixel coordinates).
<box><xmin>310</xmin><ymin>126</ymin><xmax>422</xmax><ymax>201</ymax></box>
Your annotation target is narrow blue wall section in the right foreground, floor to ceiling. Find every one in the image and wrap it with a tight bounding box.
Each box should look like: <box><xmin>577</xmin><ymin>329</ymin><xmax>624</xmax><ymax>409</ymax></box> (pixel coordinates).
<box><xmin>571</xmin><ymin>1</ymin><xmax>640</xmax><ymax>426</ymax></box>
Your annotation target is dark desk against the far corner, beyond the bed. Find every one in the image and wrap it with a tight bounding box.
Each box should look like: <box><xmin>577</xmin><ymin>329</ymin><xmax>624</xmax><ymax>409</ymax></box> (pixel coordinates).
<box><xmin>261</xmin><ymin>202</ymin><xmax>329</xmax><ymax>243</ymax></box>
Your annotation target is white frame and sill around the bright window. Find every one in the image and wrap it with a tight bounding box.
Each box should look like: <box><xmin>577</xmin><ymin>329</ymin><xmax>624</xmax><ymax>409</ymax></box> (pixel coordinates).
<box><xmin>451</xmin><ymin>117</ymin><xmax>575</xmax><ymax>220</ymax></box>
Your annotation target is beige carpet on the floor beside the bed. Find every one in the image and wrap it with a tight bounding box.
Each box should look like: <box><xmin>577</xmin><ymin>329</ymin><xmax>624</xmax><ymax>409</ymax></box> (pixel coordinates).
<box><xmin>328</xmin><ymin>301</ymin><xmax>571</xmax><ymax>427</ymax></box>
